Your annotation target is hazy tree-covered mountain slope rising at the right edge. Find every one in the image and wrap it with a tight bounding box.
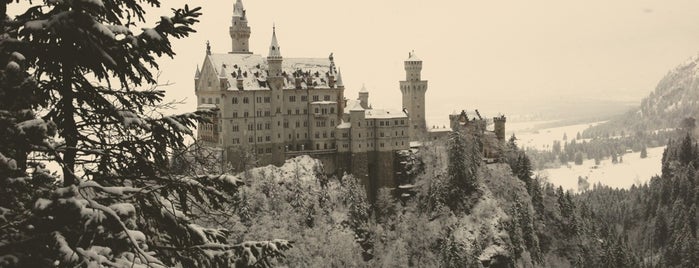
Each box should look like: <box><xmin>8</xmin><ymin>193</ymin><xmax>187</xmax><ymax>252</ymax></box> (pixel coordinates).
<box><xmin>595</xmin><ymin>55</ymin><xmax>699</xmax><ymax>133</ymax></box>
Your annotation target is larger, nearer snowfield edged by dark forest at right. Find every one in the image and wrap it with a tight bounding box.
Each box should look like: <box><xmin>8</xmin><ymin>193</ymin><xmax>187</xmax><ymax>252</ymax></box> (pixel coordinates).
<box><xmin>535</xmin><ymin>146</ymin><xmax>665</xmax><ymax>191</ymax></box>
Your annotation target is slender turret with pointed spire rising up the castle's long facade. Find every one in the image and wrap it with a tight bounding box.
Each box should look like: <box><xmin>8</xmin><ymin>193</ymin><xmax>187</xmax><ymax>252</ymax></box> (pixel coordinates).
<box><xmin>267</xmin><ymin>27</ymin><xmax>285</xmax><ymax>165</ymax></box>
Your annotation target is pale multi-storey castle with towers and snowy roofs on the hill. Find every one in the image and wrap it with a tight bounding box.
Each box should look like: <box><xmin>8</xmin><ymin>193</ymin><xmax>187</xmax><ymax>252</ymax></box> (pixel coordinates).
<box><xmin>194</xmin><ymin>0</ymin><xmax>504</xmax><ymax>197</ymax></box>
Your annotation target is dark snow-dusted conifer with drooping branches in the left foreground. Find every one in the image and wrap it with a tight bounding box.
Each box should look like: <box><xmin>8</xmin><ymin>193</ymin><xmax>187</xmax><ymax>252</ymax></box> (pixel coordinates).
<box><xmin>0</xmin><ymin>0</ymin><xmax>291</xmax><ymax>267</ymax></box>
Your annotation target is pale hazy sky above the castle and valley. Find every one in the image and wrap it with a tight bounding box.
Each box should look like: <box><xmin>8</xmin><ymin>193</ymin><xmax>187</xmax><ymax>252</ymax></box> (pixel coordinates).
<box><xmin>10</xmin><ymin>0</ymin><xmax>699</xmax><ymax>123</ymax></box>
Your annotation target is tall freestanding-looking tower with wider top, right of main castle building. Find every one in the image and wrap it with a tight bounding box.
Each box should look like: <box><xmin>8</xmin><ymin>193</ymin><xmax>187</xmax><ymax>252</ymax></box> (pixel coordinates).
<box><xmin>400</xmin><ymin>49</ymin><xmax>427</xmax><ymax>140</ymax></box>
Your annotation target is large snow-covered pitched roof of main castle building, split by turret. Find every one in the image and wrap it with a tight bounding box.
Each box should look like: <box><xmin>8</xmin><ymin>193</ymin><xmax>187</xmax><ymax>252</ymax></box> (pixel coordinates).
<box><xmin>208</xmin><ymin>53</ymin><xmax>330</xmax><ymax>90</ymax></box>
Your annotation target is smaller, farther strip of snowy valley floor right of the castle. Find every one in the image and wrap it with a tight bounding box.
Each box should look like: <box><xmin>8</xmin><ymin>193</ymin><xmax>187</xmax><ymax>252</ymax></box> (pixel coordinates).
<box><xmin>508</xmin><ymin>121</ymin><xmax>604</xmax><ymax>150</ymax></box>
